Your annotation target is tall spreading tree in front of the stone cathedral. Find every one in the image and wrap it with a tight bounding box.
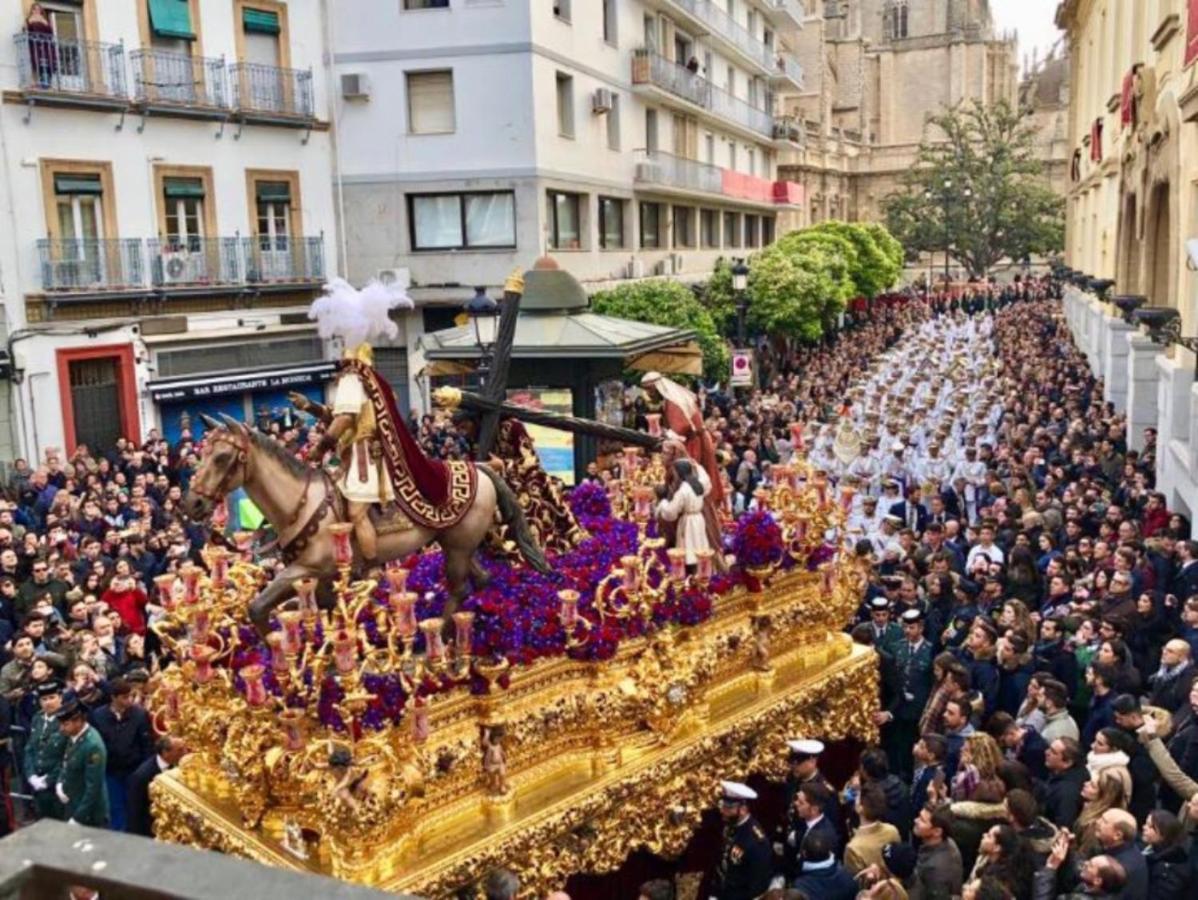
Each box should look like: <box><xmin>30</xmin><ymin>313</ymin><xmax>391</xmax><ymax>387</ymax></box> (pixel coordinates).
<box><xmin>883</xmin><ymin>102</ymin><xmax>1065</xmax><ymax>276</ymax></box>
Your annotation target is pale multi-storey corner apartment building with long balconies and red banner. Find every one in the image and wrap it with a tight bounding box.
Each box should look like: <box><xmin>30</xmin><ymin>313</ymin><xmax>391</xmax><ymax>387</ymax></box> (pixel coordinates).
<box><xmin>331</xmin><ymin>0</ymin><xmax>806</xmax><ymax>414</ymax></box>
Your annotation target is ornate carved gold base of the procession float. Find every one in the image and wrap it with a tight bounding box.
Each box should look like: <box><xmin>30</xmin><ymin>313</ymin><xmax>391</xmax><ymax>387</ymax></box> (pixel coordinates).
<box><xmin>153</xmin><ymin>572</ymin><xmax>878</xmax><ymax>898</ymax></box>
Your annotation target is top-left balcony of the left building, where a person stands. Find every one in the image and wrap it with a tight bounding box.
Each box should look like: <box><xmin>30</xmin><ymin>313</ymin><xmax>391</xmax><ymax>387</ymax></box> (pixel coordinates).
<box><xmin>13</xmin><ymin>32</ymin><xmax>128</xmax><ymax>108</ymax></box>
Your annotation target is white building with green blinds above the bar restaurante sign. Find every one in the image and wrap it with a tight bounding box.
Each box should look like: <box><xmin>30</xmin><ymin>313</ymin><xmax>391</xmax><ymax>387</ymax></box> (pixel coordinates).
<box><xmin>0</xmin><ymin>0</ymin><xmax>335</xmax><ymax>459</ymax></box>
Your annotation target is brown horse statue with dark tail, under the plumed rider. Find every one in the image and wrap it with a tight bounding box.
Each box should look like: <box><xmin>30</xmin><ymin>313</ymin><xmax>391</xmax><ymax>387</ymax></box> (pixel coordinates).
<box><xmin>182</xmin><ymin>416</ymin><xmax>549</xmax><ymax>635</ymax></box>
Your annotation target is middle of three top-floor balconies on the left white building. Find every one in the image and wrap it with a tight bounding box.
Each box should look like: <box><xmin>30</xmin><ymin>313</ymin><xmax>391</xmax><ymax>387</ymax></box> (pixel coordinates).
<box><xmin>129</xmin><ymin>50</ymin><xmax>229</xmax><ymax>117</ymax></box>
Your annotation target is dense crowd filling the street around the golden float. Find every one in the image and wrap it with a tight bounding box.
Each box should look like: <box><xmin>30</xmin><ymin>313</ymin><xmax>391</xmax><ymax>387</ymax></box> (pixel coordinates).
<box><xmin>0</xmin><ymin>274</ymin><xmax>1198</xmax><ymax>900</ymax></box>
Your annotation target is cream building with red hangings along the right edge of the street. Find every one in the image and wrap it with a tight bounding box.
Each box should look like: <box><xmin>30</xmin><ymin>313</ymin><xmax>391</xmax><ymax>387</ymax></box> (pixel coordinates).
<box><xmin>1057</xmin><ymin>0</ymin><xmax>1198</xmax><ymax>518</ymax></box>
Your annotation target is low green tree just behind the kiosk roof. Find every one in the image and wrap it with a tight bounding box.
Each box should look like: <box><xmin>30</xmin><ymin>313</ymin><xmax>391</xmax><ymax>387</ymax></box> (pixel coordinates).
<box><xmin>591</xmin><ymin>280</ymin><xmax>731</xmax><ymax>380</ymax></box>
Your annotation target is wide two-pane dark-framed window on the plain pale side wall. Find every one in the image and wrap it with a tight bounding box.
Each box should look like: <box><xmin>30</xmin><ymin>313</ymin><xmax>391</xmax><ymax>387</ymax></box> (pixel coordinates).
<box><xmin>407</xmin><ymin>191</ymin><xmax>516</xmax><ymax>250</ymax></box>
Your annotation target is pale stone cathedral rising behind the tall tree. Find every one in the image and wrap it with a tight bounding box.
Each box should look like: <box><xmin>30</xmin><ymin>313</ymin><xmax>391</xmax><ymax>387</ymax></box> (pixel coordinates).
<box><xmin>780</xmin><ymin>0</ymin><xmax>1018</xmax><ymax>228</ymax></box>
